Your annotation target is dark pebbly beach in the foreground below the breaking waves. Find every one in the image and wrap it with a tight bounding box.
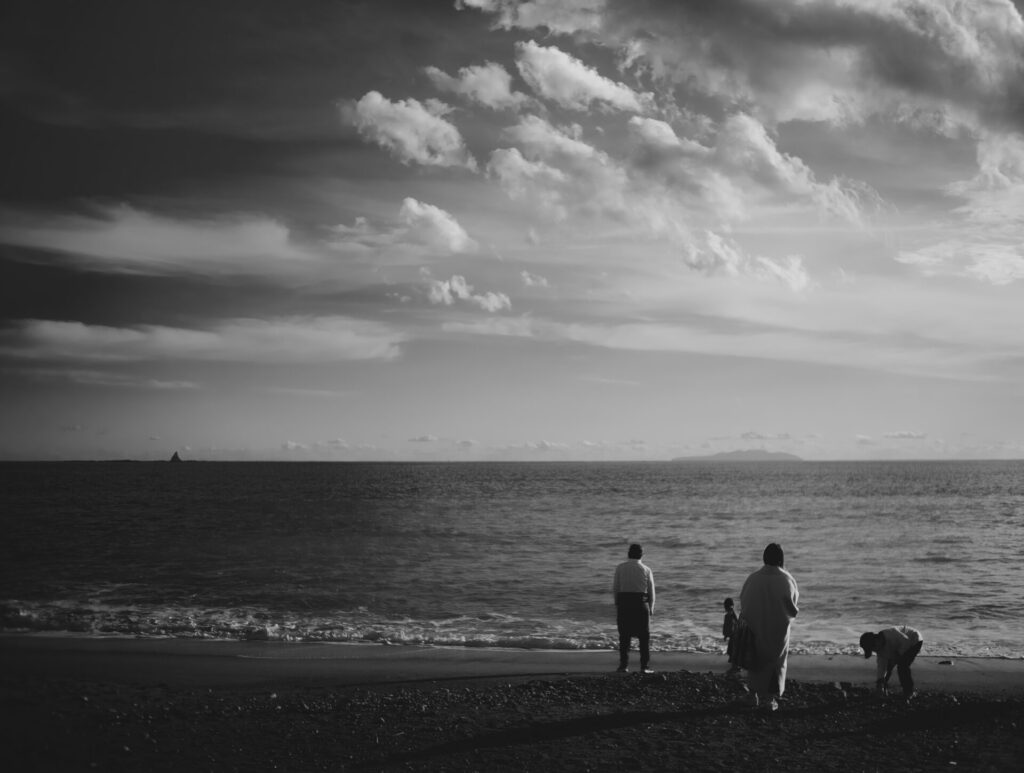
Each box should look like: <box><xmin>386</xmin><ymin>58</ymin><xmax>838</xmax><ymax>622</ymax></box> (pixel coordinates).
<box><xmin>0</xmin><ymin>635</ymin><xmax>1024</xmax><ymax>771</ymax></box>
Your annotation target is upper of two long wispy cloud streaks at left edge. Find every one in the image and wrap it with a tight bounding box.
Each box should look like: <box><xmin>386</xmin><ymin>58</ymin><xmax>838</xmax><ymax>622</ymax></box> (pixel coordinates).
<box><xmin>0</xmin><ymin>205</ymin><xmax>321</xmax><ymax>277</ymax></box>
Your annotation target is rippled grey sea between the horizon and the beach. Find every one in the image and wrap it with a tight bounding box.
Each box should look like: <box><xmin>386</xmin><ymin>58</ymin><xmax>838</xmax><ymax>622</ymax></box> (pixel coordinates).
<box><xmin>0</xmin><ymin>462</ymin><xmax>1024</xmax><ymax>658</ymax></box>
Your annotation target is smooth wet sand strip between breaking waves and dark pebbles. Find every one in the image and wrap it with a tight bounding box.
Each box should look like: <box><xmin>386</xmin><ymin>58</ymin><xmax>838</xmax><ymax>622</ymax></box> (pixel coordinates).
<box><xmin>0</xmin><ymin>634</ymin><xmax>1024</xmax><ymax>696</ymax></box>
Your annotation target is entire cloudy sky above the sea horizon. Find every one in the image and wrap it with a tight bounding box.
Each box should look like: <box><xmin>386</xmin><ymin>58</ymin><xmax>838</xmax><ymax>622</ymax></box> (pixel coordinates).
<box><xmin>0</xmin><ymin>0</ymin><xmax>1024</xmax><ymax>461</ymax></box>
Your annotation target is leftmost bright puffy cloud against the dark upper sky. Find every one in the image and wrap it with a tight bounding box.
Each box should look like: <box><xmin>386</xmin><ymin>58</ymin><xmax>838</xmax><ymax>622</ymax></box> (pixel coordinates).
<box><xmin>341</xmin><ymin>91</ymin><xmax>476</xmax><ymax>171</ymax></box>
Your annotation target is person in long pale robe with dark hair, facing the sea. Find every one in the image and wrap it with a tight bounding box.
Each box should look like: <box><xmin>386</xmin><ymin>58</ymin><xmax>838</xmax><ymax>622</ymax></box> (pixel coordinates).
<box><xmin>739</xmin><ymin>543</ymin><xmax>800</xmax><ymax>707</ymax></box>
